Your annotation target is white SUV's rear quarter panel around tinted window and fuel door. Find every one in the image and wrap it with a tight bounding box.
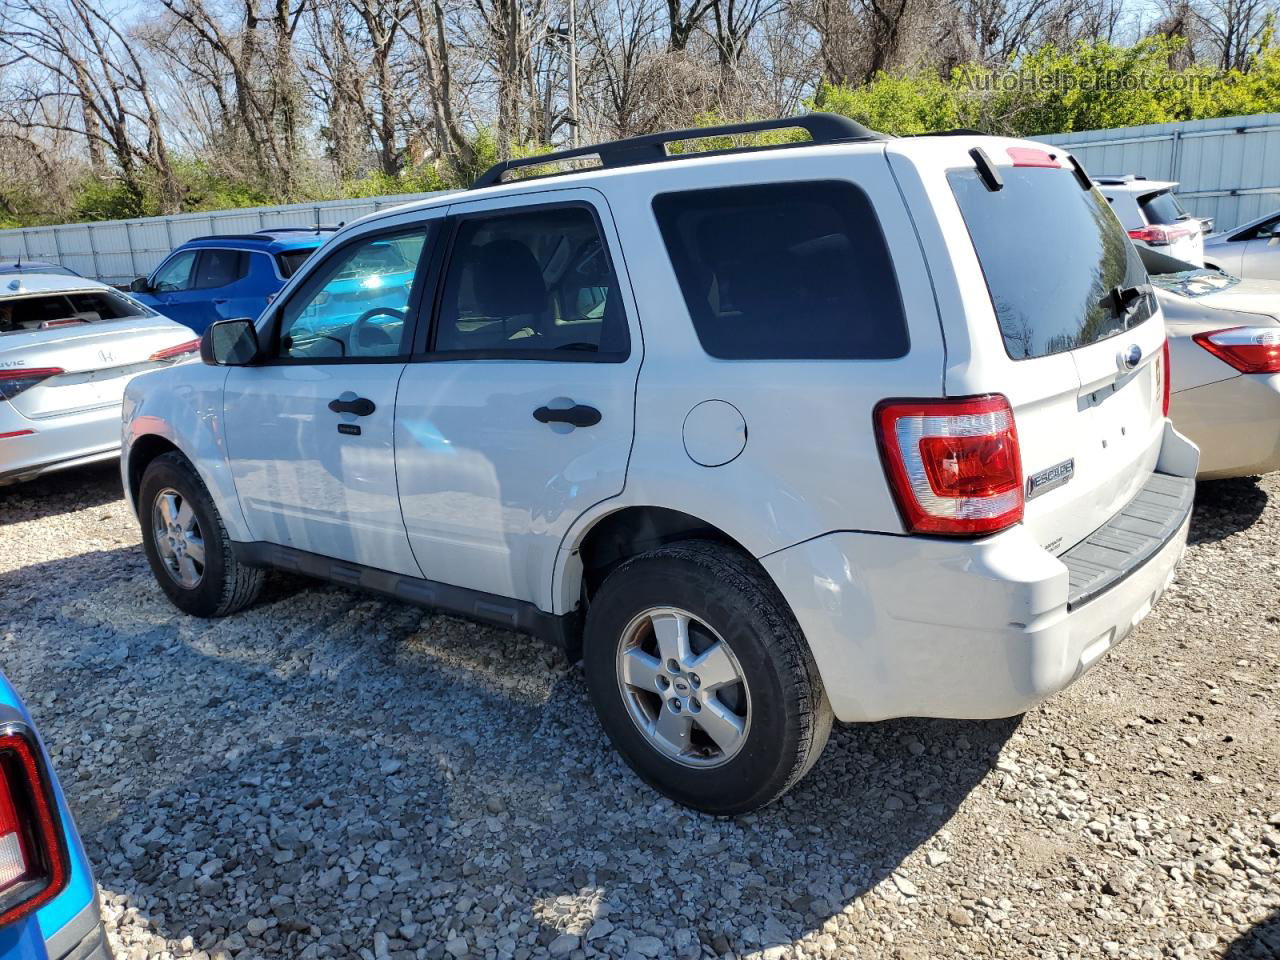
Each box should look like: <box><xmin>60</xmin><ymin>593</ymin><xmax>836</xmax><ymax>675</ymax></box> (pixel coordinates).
<box><xmin>556</xmin><ymin>143</ymin><xmax>945</xmax><ymax>609</ymax></box>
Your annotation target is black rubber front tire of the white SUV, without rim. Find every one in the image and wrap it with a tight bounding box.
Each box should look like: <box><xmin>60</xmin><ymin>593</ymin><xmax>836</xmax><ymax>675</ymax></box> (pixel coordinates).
<box><xmin>138</xmin><ymin>453</ymin><xmax>265</xmax><ymax>617</ymax></box>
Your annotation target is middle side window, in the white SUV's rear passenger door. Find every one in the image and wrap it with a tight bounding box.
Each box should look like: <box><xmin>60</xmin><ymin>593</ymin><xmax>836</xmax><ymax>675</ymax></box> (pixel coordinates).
<box><xmin>434</xmin><ymin>206</ymin><xmax>630</xmax><ymax>360</ymax></box>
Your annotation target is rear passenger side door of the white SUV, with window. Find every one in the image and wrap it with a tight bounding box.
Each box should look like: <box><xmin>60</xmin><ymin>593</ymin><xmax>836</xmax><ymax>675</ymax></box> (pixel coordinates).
<box><xmin>396</xmin><ymin>189</ymin><xmax>641</xmax><ymax>609</ymax></box>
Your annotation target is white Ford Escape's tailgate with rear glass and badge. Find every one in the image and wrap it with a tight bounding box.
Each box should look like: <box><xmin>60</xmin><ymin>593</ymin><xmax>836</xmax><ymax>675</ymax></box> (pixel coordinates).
<box><xmin>946</xmin><ymin>147</ymin><xmax>1165</xmax><ymax>553</ymax></box>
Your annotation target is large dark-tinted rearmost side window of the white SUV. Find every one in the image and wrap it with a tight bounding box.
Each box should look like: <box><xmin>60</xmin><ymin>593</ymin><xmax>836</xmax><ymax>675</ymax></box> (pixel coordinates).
<box><xmin>653</xmin><ymin>180</ymin><xmax>909</xmax><ymax>360</ymax></box>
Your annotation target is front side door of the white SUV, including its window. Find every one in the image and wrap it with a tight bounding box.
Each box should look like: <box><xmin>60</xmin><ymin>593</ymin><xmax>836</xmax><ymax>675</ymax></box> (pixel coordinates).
<box><xmin>223</xmin><ymin>215</ymin><xmax>433</xmax><ymax>576</ymax></box>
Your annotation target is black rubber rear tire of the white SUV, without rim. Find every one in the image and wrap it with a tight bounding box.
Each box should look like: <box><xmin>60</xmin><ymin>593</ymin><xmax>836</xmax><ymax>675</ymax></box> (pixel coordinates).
<box><xmin>584</xmin><ymin>540</ymin><xmax>832</xmax><ymax>815</ymax></box>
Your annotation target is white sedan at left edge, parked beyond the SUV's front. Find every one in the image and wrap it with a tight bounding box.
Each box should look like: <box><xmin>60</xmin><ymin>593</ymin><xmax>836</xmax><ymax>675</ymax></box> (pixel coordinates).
<box><xmin>0</xmin><ymin>273</ymin><xmax>200</xmax><ymax>485</ymax></box>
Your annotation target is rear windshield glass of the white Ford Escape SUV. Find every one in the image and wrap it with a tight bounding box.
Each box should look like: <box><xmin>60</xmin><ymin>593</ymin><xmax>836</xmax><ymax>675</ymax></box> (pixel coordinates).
<box><xmin>947</xmin><ymin>166</ymin><xmax>1153</xmax><ymax>360</ymax></box>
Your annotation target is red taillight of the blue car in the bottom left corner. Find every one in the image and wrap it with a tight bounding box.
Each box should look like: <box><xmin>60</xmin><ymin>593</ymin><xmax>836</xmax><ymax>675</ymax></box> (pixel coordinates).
<box><xmin>0</xmin><ymin>724</ymin><xmax>68</xmax><ymax>927</ymax></box>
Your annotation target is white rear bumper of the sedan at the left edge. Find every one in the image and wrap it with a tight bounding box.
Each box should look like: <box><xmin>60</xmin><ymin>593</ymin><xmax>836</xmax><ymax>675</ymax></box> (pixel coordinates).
<box><xmin>0</xmin><ymin>401</ymin><xmax>120</xmax><ymax>484</ymax></box>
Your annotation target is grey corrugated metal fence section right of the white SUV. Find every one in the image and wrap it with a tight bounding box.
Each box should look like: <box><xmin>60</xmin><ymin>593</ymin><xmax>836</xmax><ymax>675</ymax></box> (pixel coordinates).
<box><xmin>1036</xmin><ymin>114</ymin><xmax>1280</xmax><ymax>230</ymax></box>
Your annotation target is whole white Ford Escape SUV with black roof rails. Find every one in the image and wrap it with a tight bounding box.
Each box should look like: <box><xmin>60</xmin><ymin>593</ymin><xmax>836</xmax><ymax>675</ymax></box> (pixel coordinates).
<box><xmin>123</xmin><ymin>114</ymin><xmax>1197</xmax><ymax>814</ymax></box>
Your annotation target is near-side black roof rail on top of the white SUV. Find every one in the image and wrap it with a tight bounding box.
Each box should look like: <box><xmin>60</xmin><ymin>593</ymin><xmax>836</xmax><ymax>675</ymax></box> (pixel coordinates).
<box><xmin>471</xmin><ymin>113</ymin><xmax>886</xmax><ymax>189</ymax></box>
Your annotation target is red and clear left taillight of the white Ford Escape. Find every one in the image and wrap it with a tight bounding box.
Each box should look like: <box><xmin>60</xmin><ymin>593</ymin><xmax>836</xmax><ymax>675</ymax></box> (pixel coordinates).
<box><xmin>876</xmin><ymin>394</ymin><xmax>1023</xmax><ymax>536</ymax></box>
